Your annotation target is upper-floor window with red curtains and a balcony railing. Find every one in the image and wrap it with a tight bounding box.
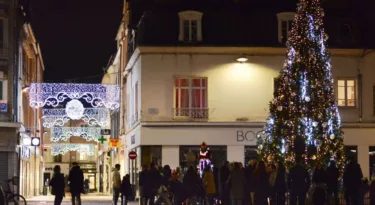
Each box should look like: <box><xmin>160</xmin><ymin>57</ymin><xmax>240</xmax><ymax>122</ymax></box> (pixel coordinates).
<box><xmin>175</xmin><ymin>78</ymin><xmax>208</xmax><ymax>119</ymax></box>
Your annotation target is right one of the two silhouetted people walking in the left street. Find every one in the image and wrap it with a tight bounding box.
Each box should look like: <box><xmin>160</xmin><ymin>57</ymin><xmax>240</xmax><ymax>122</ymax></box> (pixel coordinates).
<box><xmin>68</xmin><ymin>162</ymin><xmax>84</xmax><ymax>205</ymax></box>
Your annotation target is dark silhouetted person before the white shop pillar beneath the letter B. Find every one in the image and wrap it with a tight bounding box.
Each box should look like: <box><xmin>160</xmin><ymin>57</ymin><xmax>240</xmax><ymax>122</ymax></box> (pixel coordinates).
<box><xmin>229</xmin><ymin>162</ymin><xmax>246</xmax><ymax>205</ymax></box>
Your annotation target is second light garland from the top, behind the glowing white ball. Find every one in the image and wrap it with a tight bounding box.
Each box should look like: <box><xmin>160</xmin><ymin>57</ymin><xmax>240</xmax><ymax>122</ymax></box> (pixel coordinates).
<box><xmin>42</xmin><ymin>108</ymin><xmax>110</xmax><ymax>128</ymax></box>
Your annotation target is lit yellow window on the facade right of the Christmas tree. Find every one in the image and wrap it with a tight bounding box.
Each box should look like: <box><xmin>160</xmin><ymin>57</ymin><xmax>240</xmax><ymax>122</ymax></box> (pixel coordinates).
<box><xmin>337</xmin><ymin>79</ymin><xmax>356</xmax><ymax>107</ymax></box>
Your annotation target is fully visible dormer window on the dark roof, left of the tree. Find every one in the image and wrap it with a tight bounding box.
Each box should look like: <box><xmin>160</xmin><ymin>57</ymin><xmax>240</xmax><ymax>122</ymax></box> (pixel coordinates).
<box><xmin>178</xmin><ymin>11</ymin><xmax>203</xmax><ymax>43</ymax></box>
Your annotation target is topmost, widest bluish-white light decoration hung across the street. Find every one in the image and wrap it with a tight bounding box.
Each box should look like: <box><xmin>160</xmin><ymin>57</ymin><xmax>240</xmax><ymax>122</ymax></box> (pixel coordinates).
<box><xmin>30</xmin><ymin>83</ymin><xmax>120</xmax><ymax>110</ymax></box>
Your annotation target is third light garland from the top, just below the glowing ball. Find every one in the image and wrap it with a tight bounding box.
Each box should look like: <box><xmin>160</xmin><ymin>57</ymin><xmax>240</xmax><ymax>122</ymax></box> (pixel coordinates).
<box><xmin>51</xmin><ymin>127</ymin><xmax>101</xmax><ymax>142</ymax></box>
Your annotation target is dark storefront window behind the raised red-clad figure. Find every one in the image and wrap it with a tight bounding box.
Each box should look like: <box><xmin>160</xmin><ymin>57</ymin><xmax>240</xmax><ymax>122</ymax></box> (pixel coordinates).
<box><xmin>180</xmin><ymin>145</ymin><xmax>227</xmax><ymax>169</ymax></box>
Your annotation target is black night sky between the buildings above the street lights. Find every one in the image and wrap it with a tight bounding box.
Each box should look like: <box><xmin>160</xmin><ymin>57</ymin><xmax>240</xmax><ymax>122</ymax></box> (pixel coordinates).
<box><xmin>31</xmin><ymin>0</ymin><xmax>123</xmax><ymax>82</ymax></box>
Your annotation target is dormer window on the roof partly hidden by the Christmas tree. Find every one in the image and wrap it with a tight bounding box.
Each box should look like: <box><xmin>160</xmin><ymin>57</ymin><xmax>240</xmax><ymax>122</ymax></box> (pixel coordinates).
<box><xmin>277</xmin><ymin>12</ymin><xmax>295</xmax><ymax>44</ymax></box>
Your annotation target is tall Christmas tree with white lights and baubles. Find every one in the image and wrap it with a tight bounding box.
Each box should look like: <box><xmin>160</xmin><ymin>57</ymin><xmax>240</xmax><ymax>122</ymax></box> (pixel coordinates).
<box><xmin>258</xmin><ymin>0</ymin><xmax>345</xmax><ymax>171</ymax></box>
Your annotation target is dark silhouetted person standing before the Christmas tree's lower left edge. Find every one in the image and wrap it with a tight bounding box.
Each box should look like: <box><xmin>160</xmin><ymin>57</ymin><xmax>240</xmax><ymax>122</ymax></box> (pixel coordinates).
<box><xmin>253</xmin><ymin>161</ymin><xmax>269</xmax><ymax>205</ymax></box>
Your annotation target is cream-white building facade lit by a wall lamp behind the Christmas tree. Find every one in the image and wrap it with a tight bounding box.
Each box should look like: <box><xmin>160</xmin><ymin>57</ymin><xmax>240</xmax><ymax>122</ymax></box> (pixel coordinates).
<box><xmin>124</xmin><ymin>47</ymin><xmax>375</xmax><ymax>176</ymax></box>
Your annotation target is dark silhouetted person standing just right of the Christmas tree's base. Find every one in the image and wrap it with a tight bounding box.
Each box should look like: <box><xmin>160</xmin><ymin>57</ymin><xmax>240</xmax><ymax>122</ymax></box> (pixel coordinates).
<box><xmin>343</xmin><ymin>158</ymin><xmax>363</xmax><ymax>205</ymax></box>
